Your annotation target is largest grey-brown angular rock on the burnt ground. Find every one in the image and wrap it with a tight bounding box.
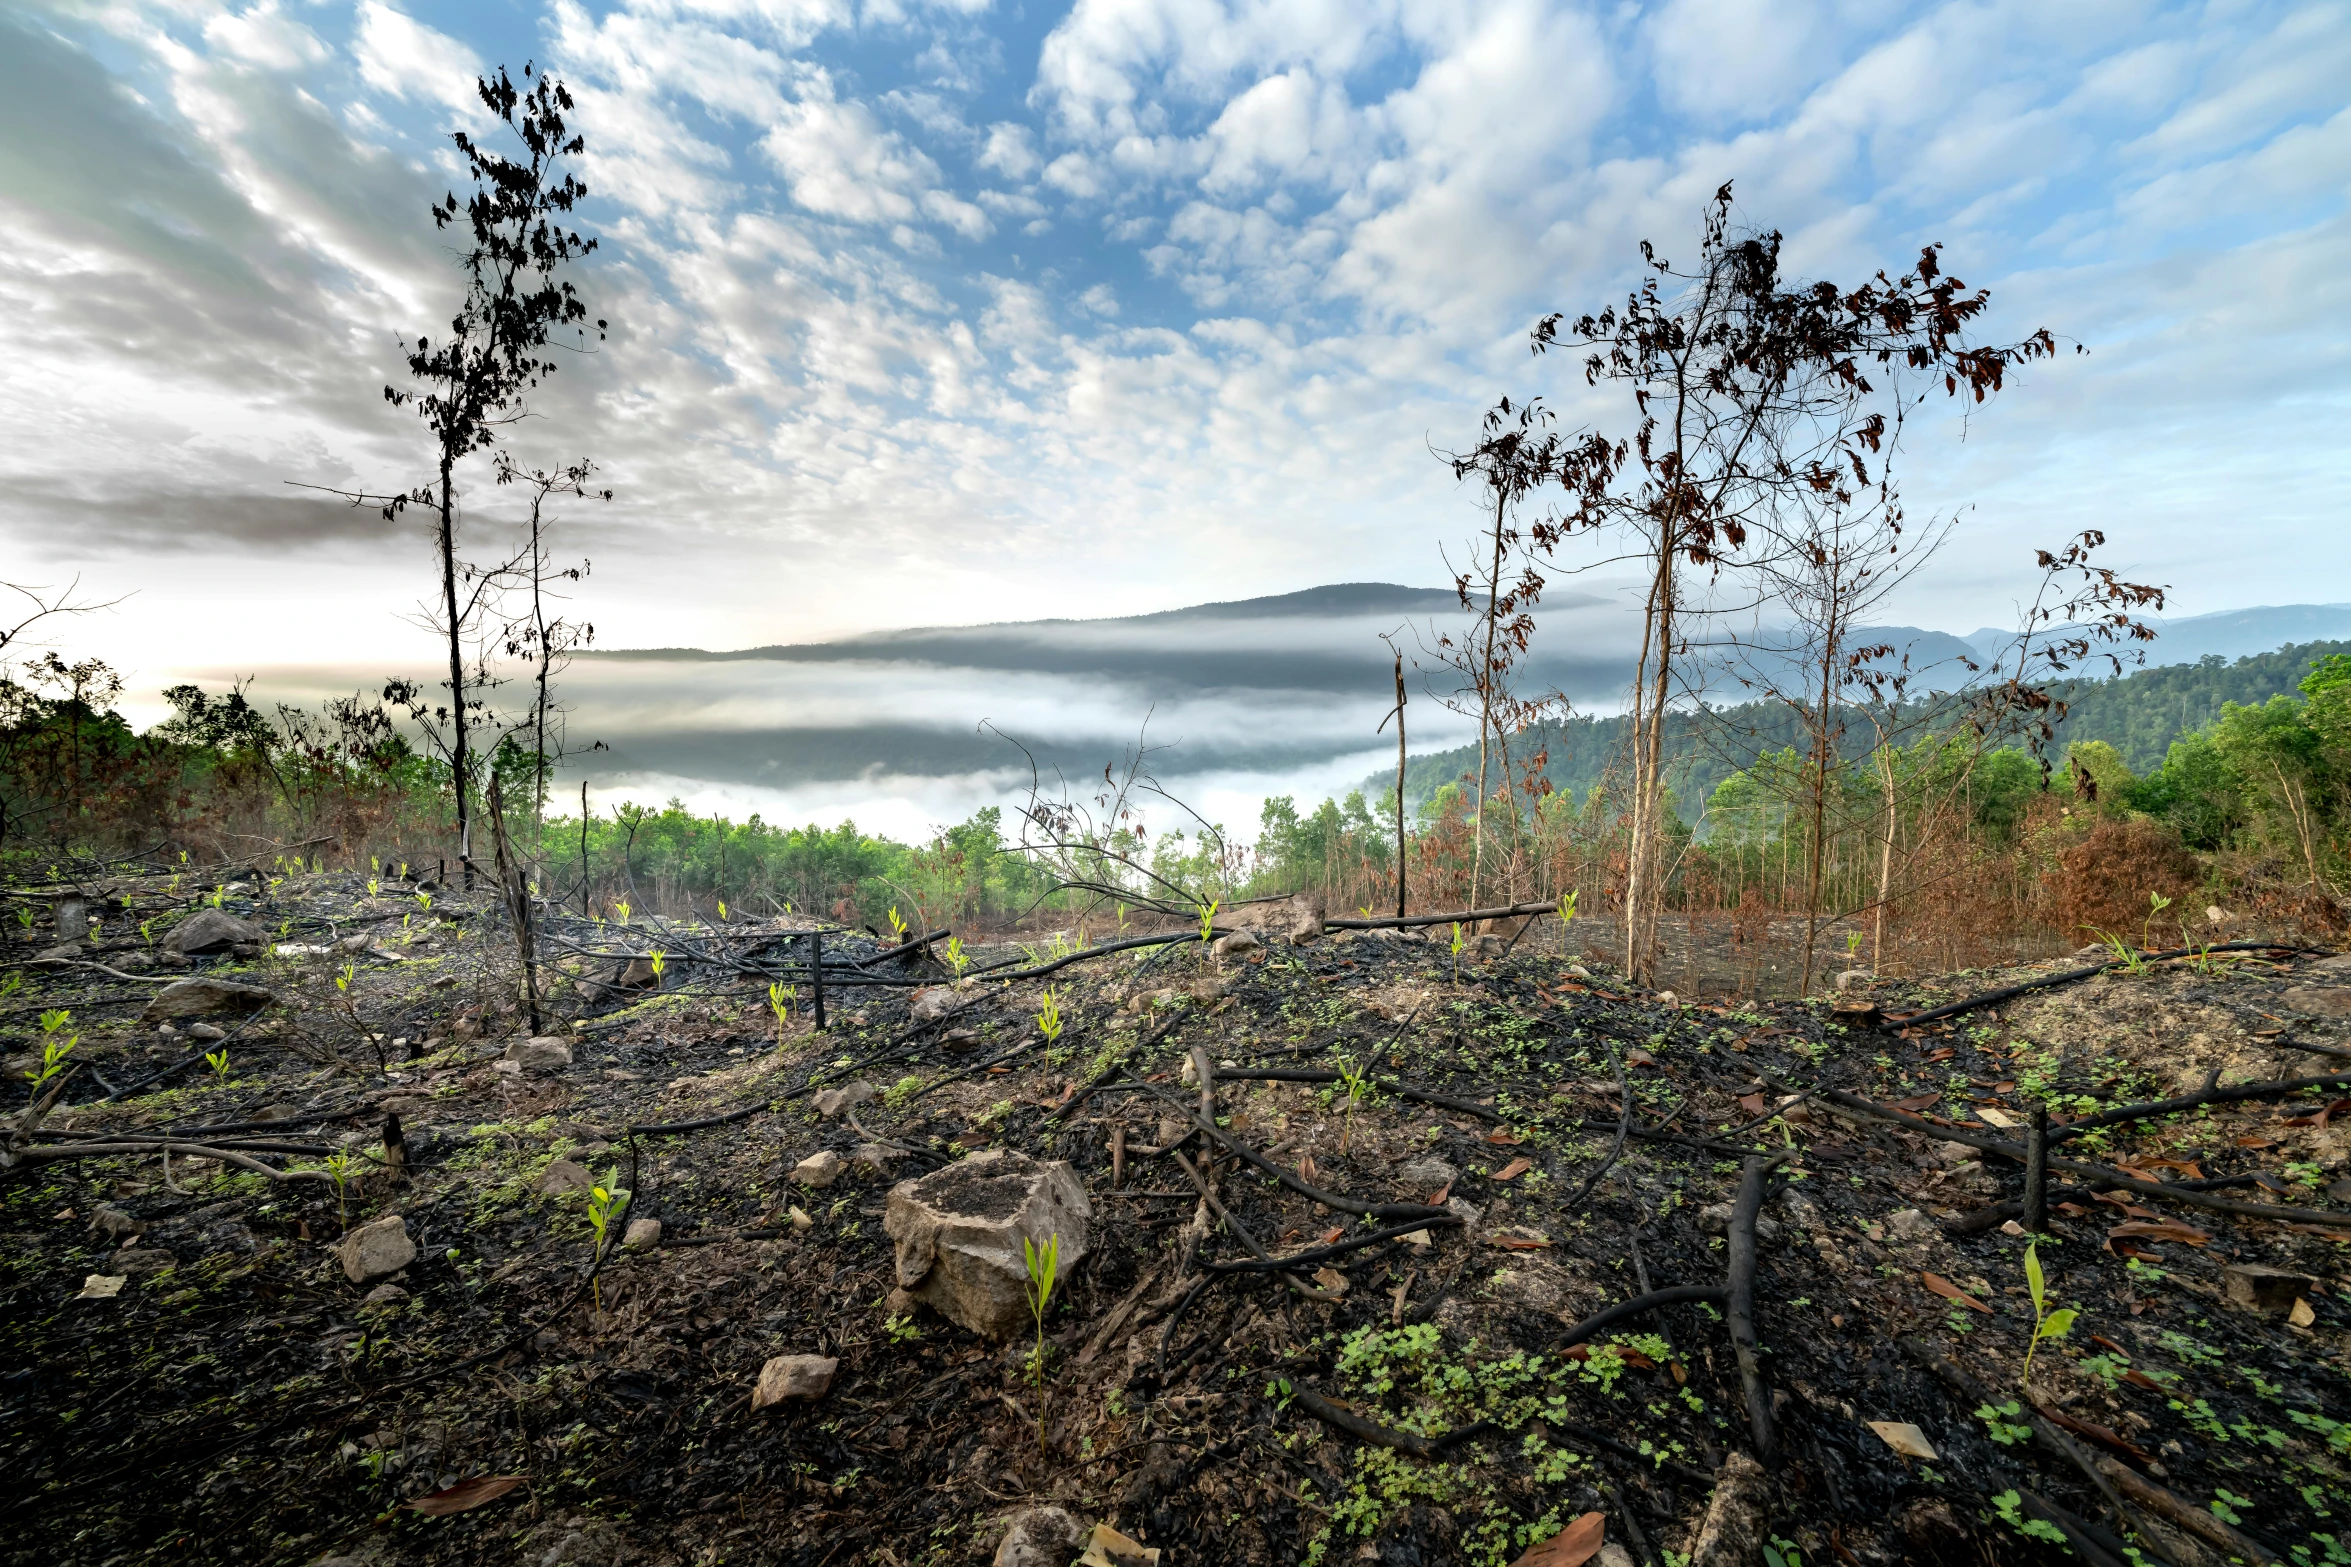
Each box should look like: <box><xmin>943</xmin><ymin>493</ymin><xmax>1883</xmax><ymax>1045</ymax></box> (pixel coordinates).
<box><xmin>882</xmin><ymin>1149</ymin><xmax>1093</xmax><ymax>1339</ymax></box>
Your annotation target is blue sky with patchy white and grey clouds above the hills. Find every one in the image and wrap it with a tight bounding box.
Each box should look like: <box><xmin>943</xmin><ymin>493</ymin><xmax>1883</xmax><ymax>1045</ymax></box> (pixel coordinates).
<box><xmin>0</xmin><ymin>0</ymin><xmax>2351</xmax><ymax>784</ymax></box>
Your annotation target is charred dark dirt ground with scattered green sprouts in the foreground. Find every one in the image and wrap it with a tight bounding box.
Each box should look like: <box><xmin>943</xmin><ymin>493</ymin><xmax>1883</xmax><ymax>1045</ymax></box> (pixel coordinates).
<box><xmin>0</xmin><ymin>874</ymin><xmax>2351</xmax><ymax>1567</ymax></box>
